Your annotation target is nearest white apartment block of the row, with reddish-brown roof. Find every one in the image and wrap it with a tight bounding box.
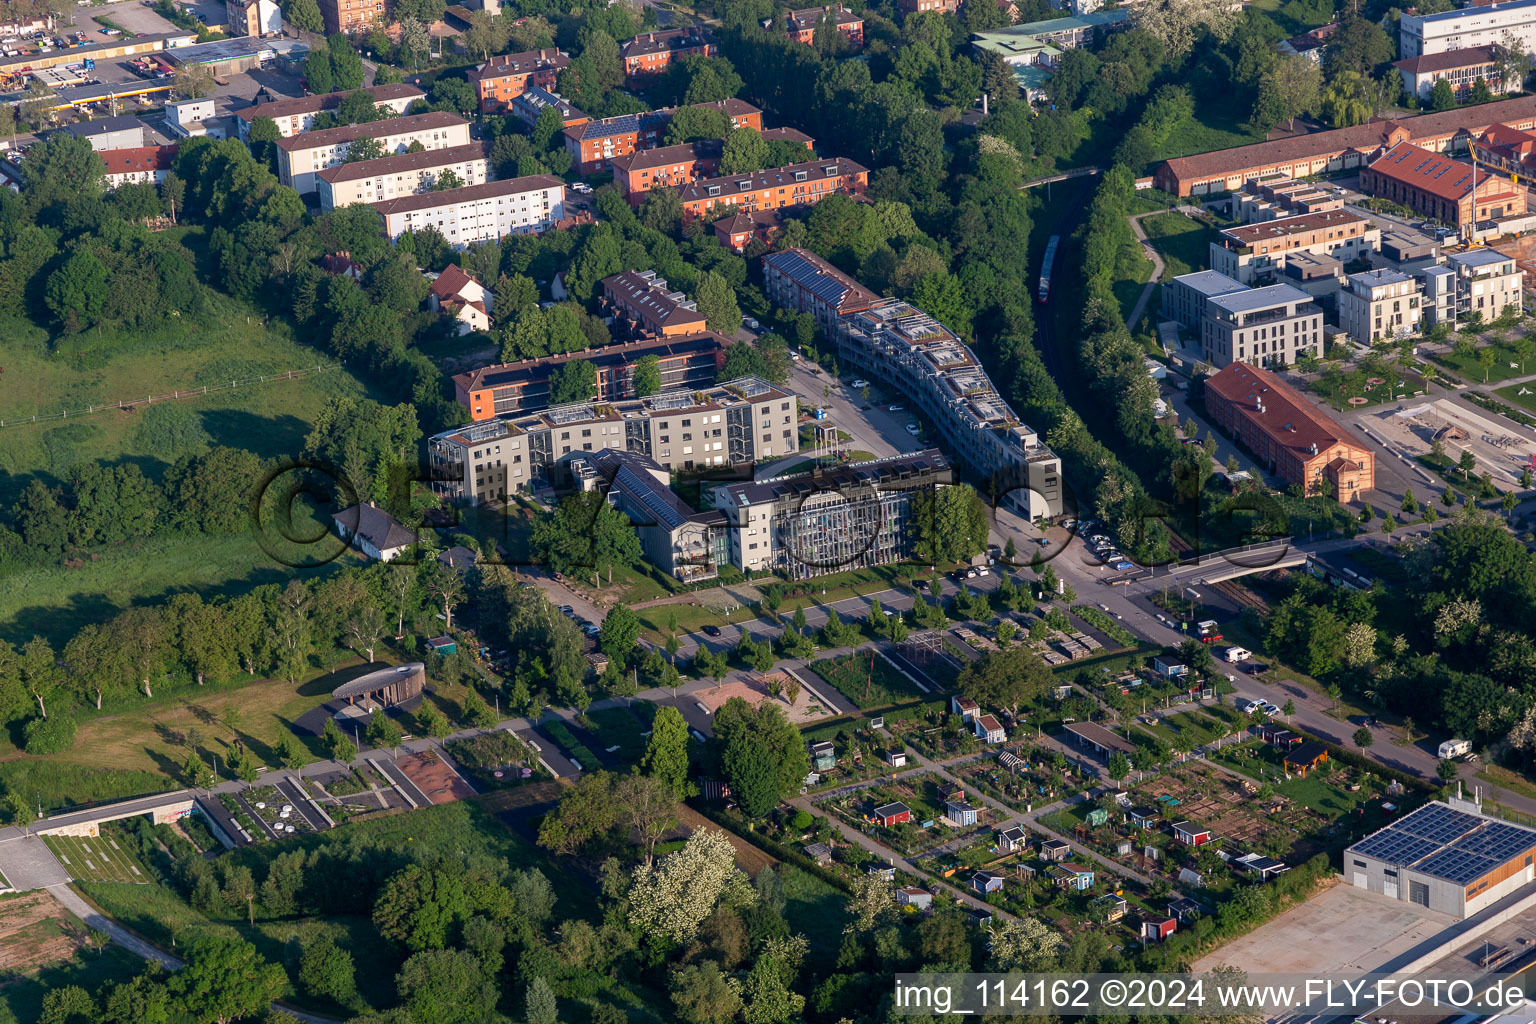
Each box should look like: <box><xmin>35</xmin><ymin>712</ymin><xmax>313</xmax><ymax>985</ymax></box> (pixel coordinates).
<box><xmin>373</xmin><ymin>173</ymin><xmax>565</xmax><ymax>249</ymax></box>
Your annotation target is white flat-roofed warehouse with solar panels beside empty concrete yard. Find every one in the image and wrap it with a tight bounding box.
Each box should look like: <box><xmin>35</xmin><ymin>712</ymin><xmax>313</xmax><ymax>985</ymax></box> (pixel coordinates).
<box><xmin>1344</xmin><ymin>801</ymin><xmax>1536</xmax><ymax>918</ymax></box>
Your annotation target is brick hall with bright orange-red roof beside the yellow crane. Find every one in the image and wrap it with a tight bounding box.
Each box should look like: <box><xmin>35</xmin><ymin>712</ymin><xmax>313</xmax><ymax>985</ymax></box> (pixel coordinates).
<box><xmin>1359</xmin><ymin>143</ymin><xmax>1525</xmax><ymax>227</ymax></box>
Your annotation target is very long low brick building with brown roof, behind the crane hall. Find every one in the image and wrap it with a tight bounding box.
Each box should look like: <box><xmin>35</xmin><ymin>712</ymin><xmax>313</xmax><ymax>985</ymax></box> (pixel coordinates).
<box><xmin>1154</xmin><ymin>94</ymin><xmax>1536</xmax><ymax>195</ymax></box>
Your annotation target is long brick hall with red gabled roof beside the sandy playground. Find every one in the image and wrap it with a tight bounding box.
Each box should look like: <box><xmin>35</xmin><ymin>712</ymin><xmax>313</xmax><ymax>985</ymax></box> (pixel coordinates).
<box><xmin>1206</xmin><ymin>362</ymin><xmax>1376</xmax><ymax>502</ymax></box>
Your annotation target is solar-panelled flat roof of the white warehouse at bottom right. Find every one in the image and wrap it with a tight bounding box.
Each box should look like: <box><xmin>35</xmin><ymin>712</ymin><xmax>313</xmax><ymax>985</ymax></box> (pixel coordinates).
<box><xmin>1344</xmin><ymin>801</ymin><xmax>1536</xmax><ymax>895</ymax></box>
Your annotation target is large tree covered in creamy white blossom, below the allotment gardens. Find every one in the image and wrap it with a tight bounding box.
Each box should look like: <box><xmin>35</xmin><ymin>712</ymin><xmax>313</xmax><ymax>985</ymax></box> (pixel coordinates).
<box><xmin>630</xmin><ymin>831</ymin><xmax>756</xmax><ymax>943</ymax></box>
